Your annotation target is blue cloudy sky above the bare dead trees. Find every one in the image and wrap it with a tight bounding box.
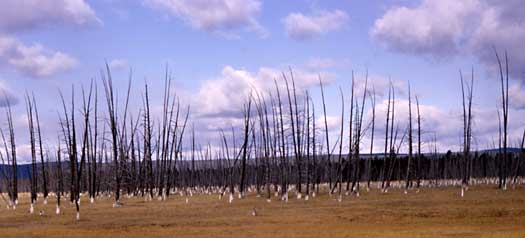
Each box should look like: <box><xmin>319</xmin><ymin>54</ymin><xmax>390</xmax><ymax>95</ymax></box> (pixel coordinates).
<box><xmin>0</xmin><ymin>0</ymin><xmax>525</xmax><ymax>162</ymax></box>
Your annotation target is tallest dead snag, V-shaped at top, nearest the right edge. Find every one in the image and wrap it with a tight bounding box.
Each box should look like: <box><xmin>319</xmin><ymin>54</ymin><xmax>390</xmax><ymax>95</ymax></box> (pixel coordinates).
<box><xmin>494</xmin><ymin>49</ymin><xmax>509</xmax><ymax>190</ymax></box>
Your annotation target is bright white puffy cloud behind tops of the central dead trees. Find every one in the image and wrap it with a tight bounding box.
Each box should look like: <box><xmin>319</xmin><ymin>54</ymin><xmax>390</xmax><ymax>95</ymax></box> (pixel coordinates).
<box><xmin>192</xmin><ymin>66</ymin><xmax>335</xmax><ymax>117</ymax></box>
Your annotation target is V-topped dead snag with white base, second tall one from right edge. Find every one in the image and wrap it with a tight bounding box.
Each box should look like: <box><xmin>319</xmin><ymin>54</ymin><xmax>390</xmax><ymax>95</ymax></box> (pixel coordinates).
<box><xmin>459</xmin><ymin>71</ymin><xmax>474</xmax><ymax>197</ymax></box>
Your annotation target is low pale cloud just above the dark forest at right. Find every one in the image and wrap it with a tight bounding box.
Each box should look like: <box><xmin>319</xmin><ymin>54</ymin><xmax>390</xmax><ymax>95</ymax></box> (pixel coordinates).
<box><xmin>364</xmin><ymin>99</ymin><xmax>508</xmax><ymax>152</ymax></box>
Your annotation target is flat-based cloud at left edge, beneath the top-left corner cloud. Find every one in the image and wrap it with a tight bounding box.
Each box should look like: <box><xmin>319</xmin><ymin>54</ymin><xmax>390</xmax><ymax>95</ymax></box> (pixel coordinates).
<box><xmin>0</xmin><ymin>35</ymin><xmax>77</xmax><ymax>77</ymax></box>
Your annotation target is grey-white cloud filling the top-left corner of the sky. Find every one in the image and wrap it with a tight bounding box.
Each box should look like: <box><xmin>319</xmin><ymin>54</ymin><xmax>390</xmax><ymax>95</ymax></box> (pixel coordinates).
<box><xmin>0</xmin><ymin>0</ymin><xmax>101</xmax><ymax>33</ymax></box>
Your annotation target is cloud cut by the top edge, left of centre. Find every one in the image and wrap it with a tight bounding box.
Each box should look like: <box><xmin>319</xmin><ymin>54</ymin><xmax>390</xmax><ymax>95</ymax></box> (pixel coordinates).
<box><xmin>145</xmin><ymin>0</ymin><xmax>268</xmax><ymax>37</ymax></box>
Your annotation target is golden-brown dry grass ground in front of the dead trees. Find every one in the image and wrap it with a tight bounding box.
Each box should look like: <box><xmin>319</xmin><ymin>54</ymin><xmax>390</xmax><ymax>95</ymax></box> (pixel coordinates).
<box><xmin>0</xmin><ymin>187</ymin><xmax>525</xmax><ymax>238</ymax></box>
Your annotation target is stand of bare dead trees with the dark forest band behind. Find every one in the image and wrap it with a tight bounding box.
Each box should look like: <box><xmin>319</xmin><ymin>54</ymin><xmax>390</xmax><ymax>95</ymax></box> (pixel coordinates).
<box><xmin>0</xmin><ymin>53</ymin><xmax>525</xmax><ymax>220</ymax></box>
